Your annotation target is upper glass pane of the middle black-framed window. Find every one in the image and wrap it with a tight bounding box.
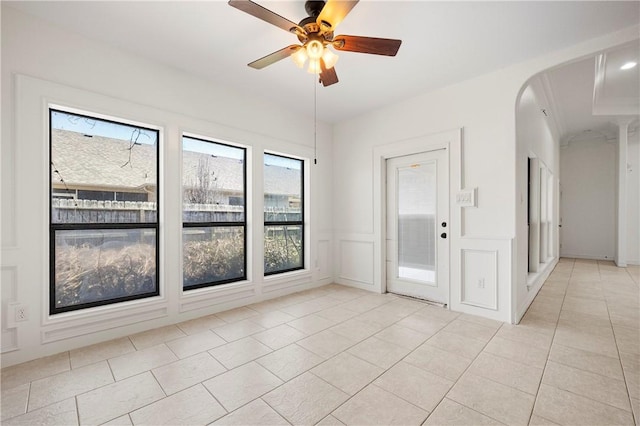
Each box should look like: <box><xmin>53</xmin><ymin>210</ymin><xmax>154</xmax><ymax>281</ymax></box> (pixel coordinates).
<box><xmin>182</xmin><ymin>136</ymin><xmax>245</xmax><ymax>222</ymax></box>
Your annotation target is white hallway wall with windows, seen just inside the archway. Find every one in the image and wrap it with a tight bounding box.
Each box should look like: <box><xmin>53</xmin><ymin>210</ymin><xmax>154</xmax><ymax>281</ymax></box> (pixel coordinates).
<box><xmin>515</xmin><ymin>75</ymin><xmax>560</xmax><ymax>320</ymax></box>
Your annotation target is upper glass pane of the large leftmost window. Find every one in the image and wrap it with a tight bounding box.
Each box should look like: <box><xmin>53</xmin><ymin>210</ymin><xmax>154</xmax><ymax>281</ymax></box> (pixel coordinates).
<box><xmin>51</xmin><ymin>110</ymin><xmax>158</xmax><ymax>223</ymax></box>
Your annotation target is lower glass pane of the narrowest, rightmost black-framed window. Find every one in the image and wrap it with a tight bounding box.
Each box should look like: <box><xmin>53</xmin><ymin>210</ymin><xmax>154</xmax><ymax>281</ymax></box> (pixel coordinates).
<box><xmin>264</xmin><ymin>225</ymin><xmax>304</xmax><ymax>274</ymax></box>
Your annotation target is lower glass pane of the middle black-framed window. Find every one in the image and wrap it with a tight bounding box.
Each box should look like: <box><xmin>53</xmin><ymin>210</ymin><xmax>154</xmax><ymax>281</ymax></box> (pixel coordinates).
<box><xmin>182</xmin><ymin>226</ymin><xmax>245</xmax><ymax>288</ymax></box>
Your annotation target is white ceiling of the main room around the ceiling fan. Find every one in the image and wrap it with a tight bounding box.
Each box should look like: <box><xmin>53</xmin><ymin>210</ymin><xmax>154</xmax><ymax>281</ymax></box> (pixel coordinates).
<box><xmin>3</xmin><ymin>0</ymin><xmax>640</xmax><ymax>123</ymax></box>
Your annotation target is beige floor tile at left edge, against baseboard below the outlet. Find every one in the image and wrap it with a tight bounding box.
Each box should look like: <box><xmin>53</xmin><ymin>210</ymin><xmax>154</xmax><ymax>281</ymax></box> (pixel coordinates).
<box><xmin>0</xmin><ymin>352</ymin><xmax>71</xmax><ymax>389</ymax></box>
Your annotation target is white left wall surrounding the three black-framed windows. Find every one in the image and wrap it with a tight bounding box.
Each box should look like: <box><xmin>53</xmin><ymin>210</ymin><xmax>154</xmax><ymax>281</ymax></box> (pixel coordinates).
<box><xmin>1</xmin><ymin>4</ymin><xmax>333</xmax><ymax>366</ymax></box>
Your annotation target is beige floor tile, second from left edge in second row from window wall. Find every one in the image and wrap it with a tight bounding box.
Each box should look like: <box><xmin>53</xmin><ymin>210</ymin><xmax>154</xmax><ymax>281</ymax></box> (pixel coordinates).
<box><xmin>28</xmin><ymin>361</ymin><xmax>113</xmax><ymax>411</ymax></box>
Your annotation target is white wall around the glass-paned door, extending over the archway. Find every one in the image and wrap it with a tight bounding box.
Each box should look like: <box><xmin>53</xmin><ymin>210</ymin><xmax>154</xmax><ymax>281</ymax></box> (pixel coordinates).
<box><xmin>333</xmin><ymin>27</ymin><xmax>637</xmax><ymax>322</ymax></box>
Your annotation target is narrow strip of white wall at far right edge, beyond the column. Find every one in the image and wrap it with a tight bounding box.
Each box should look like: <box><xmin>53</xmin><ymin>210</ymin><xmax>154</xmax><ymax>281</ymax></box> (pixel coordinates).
<box><xmin>627</xmin><ymin>131</ymin><xmax>640</xmax><ymax>265</ymax></box>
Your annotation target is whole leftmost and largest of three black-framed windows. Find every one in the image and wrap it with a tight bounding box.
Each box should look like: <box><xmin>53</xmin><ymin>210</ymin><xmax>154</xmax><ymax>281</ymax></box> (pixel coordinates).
<box><xmin>49</xmin><ymin>109</ymin><xmax>159</xmax><ymax>314</ymax></box>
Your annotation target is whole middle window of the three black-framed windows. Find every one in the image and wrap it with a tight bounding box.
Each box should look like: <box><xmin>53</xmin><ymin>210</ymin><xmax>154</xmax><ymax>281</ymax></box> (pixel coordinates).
<box><xmin>182</xmin><ymin>136</ymin><xmax>247</xmax><ymax>290</ymax></box>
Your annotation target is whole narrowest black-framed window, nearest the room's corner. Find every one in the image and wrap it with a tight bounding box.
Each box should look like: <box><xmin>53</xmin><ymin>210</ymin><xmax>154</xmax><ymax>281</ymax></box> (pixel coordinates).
<box><xmin>264</xmin><ymin>154</ymin><xmax>304</xmax><ymax>275</ymax></box>
